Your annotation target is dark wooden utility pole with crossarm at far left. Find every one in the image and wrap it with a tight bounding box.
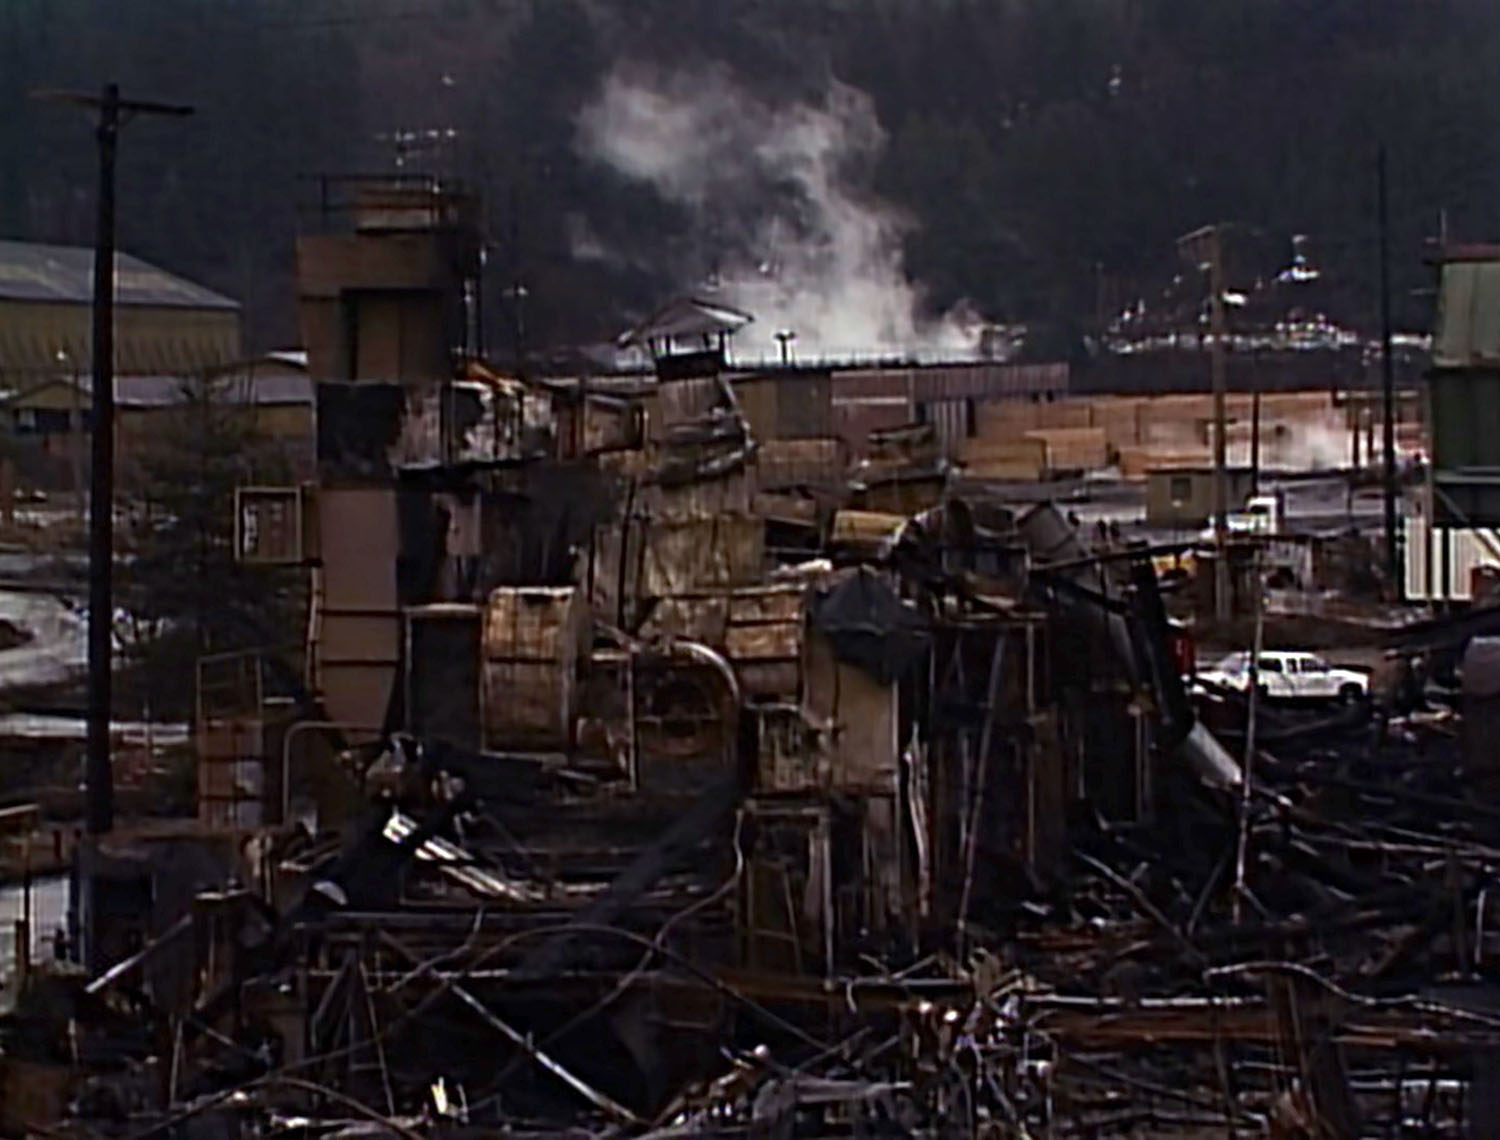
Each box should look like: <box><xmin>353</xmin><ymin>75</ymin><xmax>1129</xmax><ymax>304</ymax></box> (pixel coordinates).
<box><xmin>35</xmin><ymin>83</ymin><xmax>192</xmax><ymax>836</ymax></box>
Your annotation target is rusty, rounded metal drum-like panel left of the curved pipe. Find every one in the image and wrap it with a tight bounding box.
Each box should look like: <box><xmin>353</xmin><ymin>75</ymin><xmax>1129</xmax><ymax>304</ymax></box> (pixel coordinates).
<box><xmin>482</xmin><ymin>587</ymin><xmax>590</xmax><ymax>749</ymax></box>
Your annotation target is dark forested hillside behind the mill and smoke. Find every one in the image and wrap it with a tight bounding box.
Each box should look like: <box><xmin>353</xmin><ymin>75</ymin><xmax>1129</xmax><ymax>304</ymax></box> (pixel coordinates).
<box><xmin>0</xmin><ymin>0</ymin><xmax>1500</xmax><ymax>351</ymax></box>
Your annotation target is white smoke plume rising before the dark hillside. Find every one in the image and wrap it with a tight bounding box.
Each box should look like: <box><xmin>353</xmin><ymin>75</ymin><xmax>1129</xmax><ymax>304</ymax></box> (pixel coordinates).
<box><xmin>576</xmin><ymin>68</ymin><xmax>978</xmax><ymax>359</ymax></box>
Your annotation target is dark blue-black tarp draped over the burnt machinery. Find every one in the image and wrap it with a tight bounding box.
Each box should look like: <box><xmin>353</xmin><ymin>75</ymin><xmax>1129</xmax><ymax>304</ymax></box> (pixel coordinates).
<box><xmin>812</xmin><ymin>567</ymin><xmax>929</xmax><ymax>684</ymax></box>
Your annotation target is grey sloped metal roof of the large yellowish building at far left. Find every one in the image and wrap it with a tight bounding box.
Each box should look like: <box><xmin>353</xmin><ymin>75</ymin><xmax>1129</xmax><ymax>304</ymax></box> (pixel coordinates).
<box><xmin>0</xmin><ymin>242</ymin><xmax>240</xmax><ymax>309</ymax></box>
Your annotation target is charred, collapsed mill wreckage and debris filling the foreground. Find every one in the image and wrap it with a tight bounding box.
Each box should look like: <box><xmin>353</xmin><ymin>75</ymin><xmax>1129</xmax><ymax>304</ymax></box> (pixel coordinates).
<box><xmin>0</xmin><ymin>185</ymin><xmax>1500</xmax><ymax>1140</ymax></box>
